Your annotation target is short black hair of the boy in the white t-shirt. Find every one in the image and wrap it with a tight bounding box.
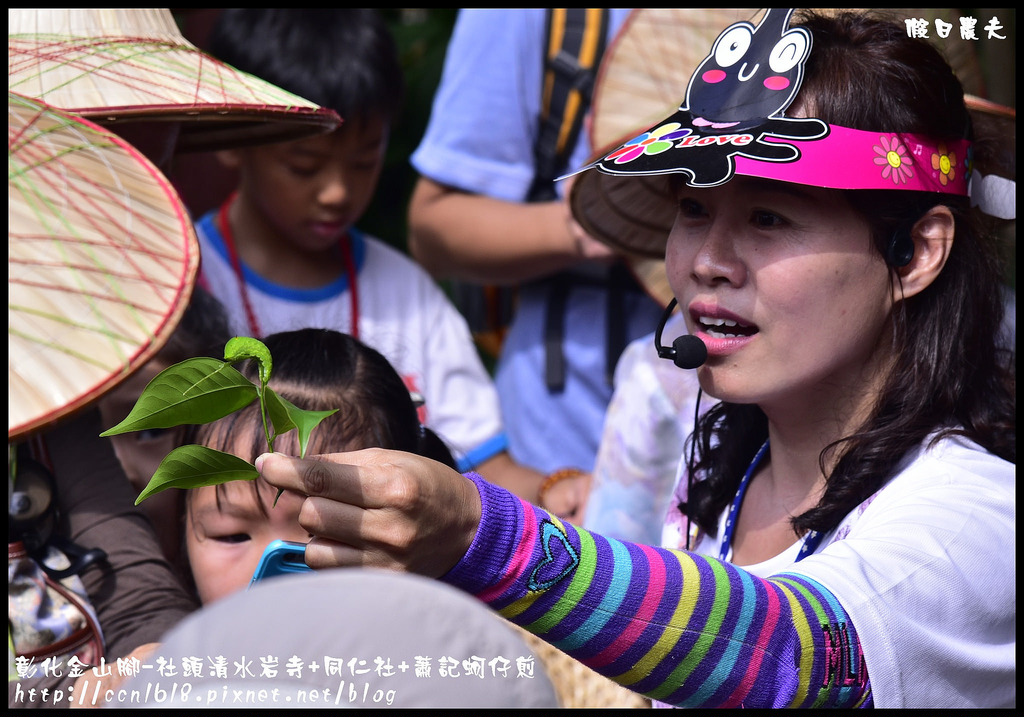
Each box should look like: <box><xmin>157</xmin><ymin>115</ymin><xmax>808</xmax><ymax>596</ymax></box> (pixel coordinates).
<box><xmin>209</xmin><ymin>7</ymin><xmax>404</xmax><ymax>123</ymax></box>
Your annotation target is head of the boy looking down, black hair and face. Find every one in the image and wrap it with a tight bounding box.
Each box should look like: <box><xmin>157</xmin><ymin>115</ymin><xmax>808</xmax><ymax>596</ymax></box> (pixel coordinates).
<box><xmin>210</xmin><ymin>8</ymin><xmax>404</xmax><ymax>252</ymax></box>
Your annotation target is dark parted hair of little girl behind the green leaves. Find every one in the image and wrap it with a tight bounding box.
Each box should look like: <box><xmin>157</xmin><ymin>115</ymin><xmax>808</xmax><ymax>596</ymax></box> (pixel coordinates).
<box><xmin>196</xmin><ymin>329</ymin><xmax>456</xmax><ymax>516</ymax></box>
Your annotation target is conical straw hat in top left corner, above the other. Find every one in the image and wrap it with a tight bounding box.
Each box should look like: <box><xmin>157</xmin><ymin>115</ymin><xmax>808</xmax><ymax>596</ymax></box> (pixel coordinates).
<box><xmin>7</xmin><ymin>8</ymin><xmax>341</xmax><ymax>152</ymax></box>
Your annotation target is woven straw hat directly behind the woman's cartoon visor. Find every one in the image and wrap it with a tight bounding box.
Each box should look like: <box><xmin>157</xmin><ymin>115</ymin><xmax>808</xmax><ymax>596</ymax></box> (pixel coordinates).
<box><xmin>570</xmin><ymin>7</ymin><xmax>1003</xmax><ymax>305</ymax></box>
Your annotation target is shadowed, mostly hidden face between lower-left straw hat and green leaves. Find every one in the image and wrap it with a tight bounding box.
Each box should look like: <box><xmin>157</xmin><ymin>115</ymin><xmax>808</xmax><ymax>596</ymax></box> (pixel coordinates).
<box><xmin>99</xmin><ymin>359</ymin><xmax>184</xmax><ymax>560</ymax></box>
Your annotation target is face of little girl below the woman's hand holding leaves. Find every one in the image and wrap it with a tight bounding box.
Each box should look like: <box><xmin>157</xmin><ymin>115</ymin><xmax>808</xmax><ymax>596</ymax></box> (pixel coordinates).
<box><xmin>185</xmin><ymin>479</ymin><xmax>310</xmax><ymax>604</ymax></box>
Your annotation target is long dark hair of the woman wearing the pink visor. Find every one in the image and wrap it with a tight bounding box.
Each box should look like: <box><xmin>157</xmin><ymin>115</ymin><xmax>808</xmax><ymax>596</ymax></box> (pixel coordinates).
<box><xmin>681</xmin><ymin>11</ymin><xmax>1016</xmax><ymax>535</ymax></box>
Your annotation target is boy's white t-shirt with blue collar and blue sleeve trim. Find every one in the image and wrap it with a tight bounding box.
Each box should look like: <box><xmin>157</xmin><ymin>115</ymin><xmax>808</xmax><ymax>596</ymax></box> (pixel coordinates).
<box><xmin>196</xmin><ymin>212</ymin><xmax>508</xmax><ymax>470</ymax></box>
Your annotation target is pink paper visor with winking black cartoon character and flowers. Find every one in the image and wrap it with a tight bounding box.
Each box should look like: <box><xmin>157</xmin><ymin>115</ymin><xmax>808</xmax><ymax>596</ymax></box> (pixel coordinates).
<box><xmin>573</xmin><ymin>8</ymin><xmax>1016</xmax><ymax>218</ymax></box>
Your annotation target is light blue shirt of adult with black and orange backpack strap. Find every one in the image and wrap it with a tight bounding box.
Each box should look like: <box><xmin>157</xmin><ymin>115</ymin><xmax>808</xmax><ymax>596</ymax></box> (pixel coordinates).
<box><xmin>412</xmin><ymin>8</ymin><xmax>662</xmax><ymax>472</ymax></box>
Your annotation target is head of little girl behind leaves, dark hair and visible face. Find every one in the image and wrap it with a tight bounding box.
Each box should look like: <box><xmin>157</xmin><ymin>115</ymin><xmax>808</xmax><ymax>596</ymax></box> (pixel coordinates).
<box><xmin>184</xmin><ymin>329</ymin><xmax>456</xmax><ymax>603</ymax></box>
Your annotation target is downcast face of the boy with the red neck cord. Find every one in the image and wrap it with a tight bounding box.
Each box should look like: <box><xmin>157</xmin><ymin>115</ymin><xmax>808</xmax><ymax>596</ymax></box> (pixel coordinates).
<box><xmin>225</xmin><ymin>120</ymin><xmax>388</xmax><ymax>254</ymax></box>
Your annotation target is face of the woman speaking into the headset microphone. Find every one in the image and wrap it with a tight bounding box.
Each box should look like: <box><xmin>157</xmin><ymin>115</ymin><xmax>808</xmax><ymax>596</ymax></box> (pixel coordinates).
<box><xmin>666</xmin><ymin>177</ymin><xmax>891</xmax><ymax>420</ymax></box>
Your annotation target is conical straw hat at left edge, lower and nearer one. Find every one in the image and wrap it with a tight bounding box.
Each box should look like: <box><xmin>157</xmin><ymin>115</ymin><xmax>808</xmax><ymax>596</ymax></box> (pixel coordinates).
<box><xmin>7</xmin><ymin>92</ymin><xmax>199</xmax><ymax>440</ymax></box>
